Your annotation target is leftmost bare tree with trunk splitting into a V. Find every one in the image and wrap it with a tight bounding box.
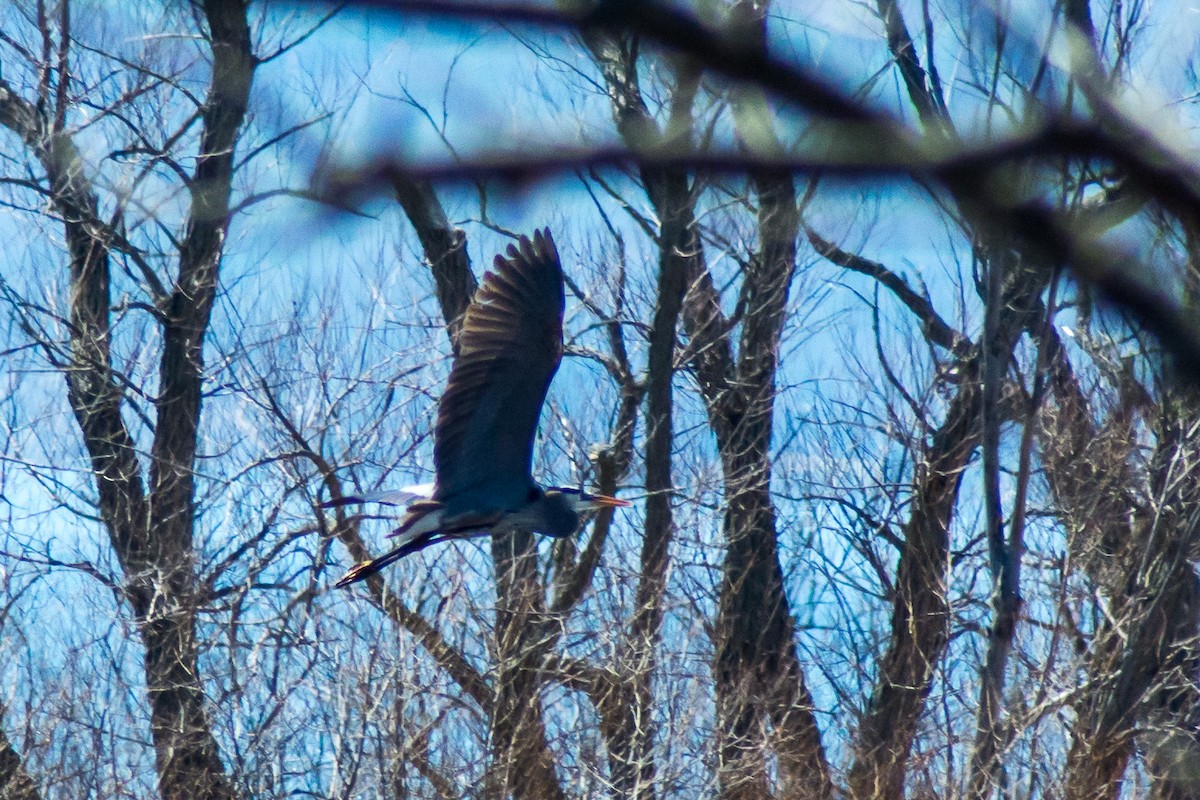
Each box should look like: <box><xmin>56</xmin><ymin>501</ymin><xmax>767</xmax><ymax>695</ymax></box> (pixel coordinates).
<box><xmin>0</xmin><ymin>1</ymin><xmax>254</xmax><ymax>798</ymax></box>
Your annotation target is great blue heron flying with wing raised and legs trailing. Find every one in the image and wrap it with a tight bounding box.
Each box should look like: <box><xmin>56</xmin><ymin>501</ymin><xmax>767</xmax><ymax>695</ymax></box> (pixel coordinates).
<box><xmin>323</xmin><ymin>229</ymin><xmax>630</xmax><ymax>587</ymax></box>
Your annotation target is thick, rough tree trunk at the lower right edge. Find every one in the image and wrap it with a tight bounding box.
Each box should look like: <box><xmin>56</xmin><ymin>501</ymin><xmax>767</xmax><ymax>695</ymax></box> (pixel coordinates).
<box><xmin>1040</xmin><ymin>319</ymin><xmax>1200</xmax><ymax>800</ymax></box>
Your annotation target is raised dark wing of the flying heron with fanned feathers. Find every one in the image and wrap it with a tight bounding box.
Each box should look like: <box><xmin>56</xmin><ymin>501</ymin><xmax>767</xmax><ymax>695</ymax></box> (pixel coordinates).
<box><xmin>433</xmin><ymin>230</ymin><xmax>564</xmax><ymax>513</ymax></box>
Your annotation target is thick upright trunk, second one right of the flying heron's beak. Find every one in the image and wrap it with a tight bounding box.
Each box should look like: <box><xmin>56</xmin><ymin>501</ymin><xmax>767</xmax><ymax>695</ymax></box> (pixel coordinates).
<box><xmin>705</xmin><ymin>15</ymin><xmax>833</xmax><ymax>786</ymax></box>
